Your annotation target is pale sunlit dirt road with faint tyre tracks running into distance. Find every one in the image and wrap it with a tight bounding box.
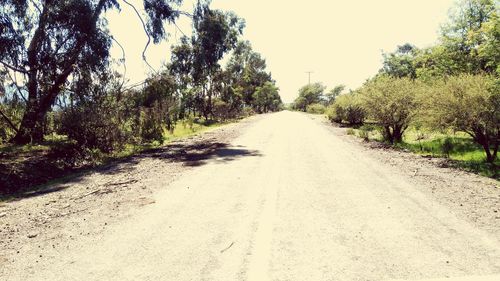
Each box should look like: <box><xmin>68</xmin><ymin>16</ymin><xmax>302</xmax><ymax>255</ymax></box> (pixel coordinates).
<box><xmin>0</xmin><ymin>111</ymin><xmax>500</xmax><ymax>281</ymax></box>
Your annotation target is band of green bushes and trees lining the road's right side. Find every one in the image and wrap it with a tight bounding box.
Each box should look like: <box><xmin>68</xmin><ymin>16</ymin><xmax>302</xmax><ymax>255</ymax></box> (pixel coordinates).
<box><xmin>293</xmin><ymin>0</ymin><xmax>500</xmax><ymax>179</ymax></box>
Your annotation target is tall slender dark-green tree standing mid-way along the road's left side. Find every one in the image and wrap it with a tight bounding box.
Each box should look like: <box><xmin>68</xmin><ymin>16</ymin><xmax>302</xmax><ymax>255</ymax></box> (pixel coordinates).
<box><xmin>169</xmin><ymin>5</ymin><xmax>245</xmax><ymax>119</ymax></box>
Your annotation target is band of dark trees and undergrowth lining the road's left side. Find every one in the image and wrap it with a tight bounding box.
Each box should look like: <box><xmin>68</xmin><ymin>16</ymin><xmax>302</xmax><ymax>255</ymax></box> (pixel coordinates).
<box><xmin>0</xmin><ymin>0</ymin><xmax>283</xmax><ymax>193</ymax></box>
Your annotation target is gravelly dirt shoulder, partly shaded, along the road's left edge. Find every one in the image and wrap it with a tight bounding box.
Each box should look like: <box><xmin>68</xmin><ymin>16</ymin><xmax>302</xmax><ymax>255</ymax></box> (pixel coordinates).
<box><xmin>0</xmin><ymin>116</ymin><xmax>258</xmax><ymax>274</ymax></box>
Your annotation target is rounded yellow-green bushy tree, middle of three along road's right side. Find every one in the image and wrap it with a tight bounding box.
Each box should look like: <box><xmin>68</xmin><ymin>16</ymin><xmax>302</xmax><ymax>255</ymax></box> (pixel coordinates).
<box><xmin>361</xmin><ymin>75</ymin><xmax>421</xmax><ymax>143</ymax></box>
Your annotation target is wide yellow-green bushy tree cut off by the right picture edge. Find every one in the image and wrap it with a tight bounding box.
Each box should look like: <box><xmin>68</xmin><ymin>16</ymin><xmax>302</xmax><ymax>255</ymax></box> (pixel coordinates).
<box><xmin>422</xmin><ymin>74</ymin><xmax>500</xmax><ymax>163</ymax></box>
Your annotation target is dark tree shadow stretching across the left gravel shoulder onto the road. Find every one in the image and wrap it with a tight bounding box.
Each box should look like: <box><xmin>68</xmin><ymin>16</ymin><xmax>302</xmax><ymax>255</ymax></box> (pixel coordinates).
<box><xmin>0</xmin><ymin>141</ymin><xmax>262</xmax><ymax>201</ymax></box>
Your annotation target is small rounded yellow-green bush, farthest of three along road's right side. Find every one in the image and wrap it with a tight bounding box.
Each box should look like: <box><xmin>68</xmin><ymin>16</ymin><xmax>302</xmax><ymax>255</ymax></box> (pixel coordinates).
<box><xmin>327</xmin><ymin>94</ymin><xmax>365</xmax><ymax>125</ymax></box>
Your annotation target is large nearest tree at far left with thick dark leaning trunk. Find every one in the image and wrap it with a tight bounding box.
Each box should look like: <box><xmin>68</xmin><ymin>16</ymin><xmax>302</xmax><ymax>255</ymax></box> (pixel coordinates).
<box><xmin>0</xmin><ymin>0</ymin><xmax>198</xmax><ymax>144</ymax></box>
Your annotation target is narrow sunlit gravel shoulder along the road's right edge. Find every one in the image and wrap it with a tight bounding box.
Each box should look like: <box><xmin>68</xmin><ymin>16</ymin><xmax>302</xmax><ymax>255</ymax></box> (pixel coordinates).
<box><xmin>310</xmin><ymin>115</ymin><xmax>500</xmax><ymax>240</ymax></box>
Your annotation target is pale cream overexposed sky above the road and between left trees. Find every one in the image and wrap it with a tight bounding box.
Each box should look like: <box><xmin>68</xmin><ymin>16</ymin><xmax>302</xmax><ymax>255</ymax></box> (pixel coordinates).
<box><xmin>107</xmin><ymin>0</ymin><xmax>455</xmax><ymax>102</ymax></box>
